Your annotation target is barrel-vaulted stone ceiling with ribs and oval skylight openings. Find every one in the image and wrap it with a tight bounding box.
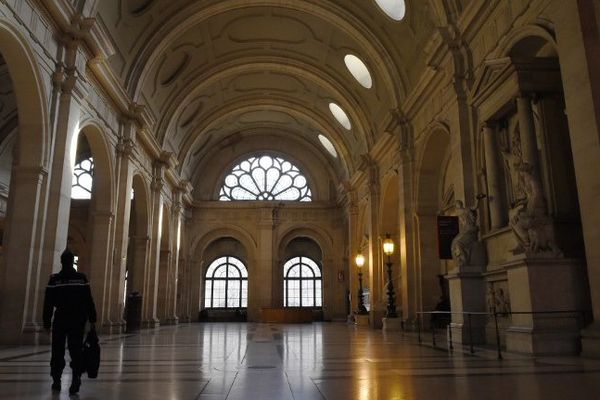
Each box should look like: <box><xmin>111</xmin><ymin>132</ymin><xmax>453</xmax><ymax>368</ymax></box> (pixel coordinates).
<box><xmin>98</xmin><ymin>0</ymin><xmax>434</xmax><ymax>182</ymax></box>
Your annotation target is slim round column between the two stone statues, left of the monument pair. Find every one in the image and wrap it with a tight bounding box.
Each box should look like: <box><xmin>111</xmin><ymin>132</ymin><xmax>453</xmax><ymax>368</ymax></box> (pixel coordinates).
<box><xmin>482</xmin><ymin>122</ymin><xmax>507</xmax><ymax>230</ymax></box>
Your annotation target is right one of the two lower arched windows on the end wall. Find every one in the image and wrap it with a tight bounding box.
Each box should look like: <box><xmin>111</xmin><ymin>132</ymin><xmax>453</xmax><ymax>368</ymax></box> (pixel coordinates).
<box><xmin>283</xmin><ymin>257</ymin><xmax>322</xmax><ymax>307</ymax></box>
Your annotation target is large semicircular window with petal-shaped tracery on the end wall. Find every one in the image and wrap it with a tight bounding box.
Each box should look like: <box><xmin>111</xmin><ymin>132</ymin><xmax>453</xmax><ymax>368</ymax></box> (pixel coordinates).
<box><xmin>219</xmin><ymin>155</ymin><xmax>312</xmax><ymax>201</ymax></box>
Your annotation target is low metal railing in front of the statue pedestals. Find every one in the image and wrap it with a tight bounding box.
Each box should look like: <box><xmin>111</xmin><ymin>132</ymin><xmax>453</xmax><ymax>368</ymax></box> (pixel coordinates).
<box><xmin>417</xmin><ymin>310</ymin><xmax>586</xmax><ymax>360</ymax></box>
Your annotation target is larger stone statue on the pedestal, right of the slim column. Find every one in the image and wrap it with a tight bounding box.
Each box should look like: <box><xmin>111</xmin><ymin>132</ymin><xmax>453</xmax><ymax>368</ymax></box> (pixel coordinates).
<box><xmin>509</xmin><ymin>162</ymin><xmax>561</xmax><ymax>255</ymax></box>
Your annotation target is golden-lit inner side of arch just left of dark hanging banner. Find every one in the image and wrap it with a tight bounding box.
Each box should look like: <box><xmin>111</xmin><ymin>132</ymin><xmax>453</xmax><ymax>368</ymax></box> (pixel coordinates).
<box><xmin>414</xmin><ymin>126</ymin><xmax>450</xmax><ymax>311</ymax></box>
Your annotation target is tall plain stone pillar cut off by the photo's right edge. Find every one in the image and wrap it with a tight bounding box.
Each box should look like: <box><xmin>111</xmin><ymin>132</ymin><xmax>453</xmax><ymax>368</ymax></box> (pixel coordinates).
<box><xmin>552</xmin><ymin>0</ymin><xmax>600</xmax><ymax>357</ymax></box>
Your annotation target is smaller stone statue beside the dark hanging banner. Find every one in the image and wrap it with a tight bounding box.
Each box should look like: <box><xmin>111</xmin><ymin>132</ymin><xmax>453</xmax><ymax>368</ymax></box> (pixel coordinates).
<box><xmin>451</xmin><ymin>194</ymin><xmax>485</xmax><ymax>267</ymax></box>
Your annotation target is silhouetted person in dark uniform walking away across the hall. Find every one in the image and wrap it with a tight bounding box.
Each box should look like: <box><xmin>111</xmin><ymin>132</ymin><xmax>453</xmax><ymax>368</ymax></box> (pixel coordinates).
<box><xmin>44</xmin><ymin>249</ymin><xmax>96</xmax><ymax>394</ymax></box>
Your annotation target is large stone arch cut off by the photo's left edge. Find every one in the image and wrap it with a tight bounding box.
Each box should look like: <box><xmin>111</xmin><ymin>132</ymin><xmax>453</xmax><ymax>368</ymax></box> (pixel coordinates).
<box><xmin>0</xmin><ymin>18</ymin><xmax>51</xmax><ymax>343</ymax></box>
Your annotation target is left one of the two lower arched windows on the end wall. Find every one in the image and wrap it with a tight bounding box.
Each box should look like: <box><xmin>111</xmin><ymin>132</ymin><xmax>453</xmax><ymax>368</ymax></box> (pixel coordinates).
<box><xmin>204</xmin><ymin>256</ymin><xmax>248</xmax><ymax>308</ymax></box>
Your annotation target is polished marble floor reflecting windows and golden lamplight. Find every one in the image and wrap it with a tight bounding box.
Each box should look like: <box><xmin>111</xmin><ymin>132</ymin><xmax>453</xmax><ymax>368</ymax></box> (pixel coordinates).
<box><xmin>0</xmin><ymin>323</ymin><xmax>600</xmax><ymax>400</ymax></box>
